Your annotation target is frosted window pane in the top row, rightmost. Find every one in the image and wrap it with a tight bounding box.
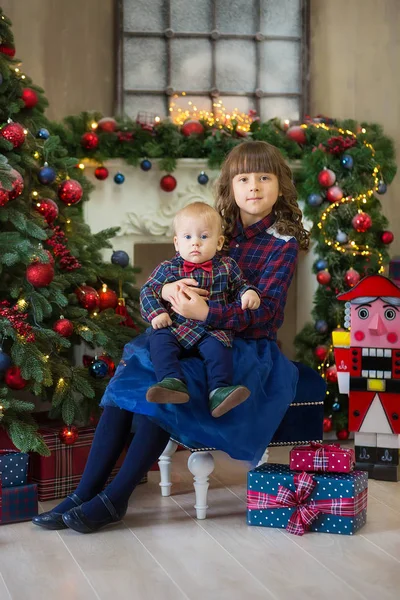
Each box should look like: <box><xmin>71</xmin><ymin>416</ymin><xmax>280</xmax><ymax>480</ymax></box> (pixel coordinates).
<box><xmin>261</xmin><ymin>0</ymin><xmax>301</xmax><ymax>36</ymax></box>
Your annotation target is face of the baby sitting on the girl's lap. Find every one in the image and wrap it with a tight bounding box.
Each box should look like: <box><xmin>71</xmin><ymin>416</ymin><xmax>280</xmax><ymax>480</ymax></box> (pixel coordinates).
<box><xmin>174</xmin><ymin>216</ymin><xmax>224</xmax><ymax>264</ymax></box>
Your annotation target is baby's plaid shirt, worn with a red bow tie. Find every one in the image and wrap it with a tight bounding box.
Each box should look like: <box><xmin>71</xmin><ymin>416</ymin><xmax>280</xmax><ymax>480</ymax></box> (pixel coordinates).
<box><xmin>140</xmin><ymin>254</ymin><xmax>253</xmax><ymax>348</ymax></box>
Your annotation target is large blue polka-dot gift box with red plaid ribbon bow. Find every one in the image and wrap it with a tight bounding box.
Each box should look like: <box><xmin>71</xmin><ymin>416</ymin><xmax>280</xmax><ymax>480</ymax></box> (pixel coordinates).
<box><xmin>247</xmin><ymin>464</ymin><xmax>368</xmax><ymax>535</ymax></box>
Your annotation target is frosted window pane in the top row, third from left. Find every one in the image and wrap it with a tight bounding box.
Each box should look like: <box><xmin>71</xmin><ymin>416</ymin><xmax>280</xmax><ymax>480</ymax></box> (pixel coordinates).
<box><xmin>217</xmin><ymin>0</ymin><xmax>258</xmax><ymax>34</ymax></box>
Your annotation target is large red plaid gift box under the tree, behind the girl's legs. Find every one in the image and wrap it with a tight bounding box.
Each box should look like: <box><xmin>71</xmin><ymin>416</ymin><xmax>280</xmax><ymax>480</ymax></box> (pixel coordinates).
<box><xmin>29</xmin><ymin>424</ymin><xmax>147</xmax><ymax>501</ymax></box>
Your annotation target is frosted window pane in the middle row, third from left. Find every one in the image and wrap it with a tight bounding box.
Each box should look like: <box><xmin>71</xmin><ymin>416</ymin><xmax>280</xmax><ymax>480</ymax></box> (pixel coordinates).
<box><xmin>215</xmin><ymin>40</ymin><xmax>256</xmax><ymax>92</ymax></box>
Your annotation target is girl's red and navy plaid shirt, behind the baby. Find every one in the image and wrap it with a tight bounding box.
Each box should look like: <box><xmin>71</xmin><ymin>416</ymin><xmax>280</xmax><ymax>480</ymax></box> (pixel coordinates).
<box><xmin>204</xmin><ymin>214</ymin><xmax>299</xmax><ymax>340</ymax></box>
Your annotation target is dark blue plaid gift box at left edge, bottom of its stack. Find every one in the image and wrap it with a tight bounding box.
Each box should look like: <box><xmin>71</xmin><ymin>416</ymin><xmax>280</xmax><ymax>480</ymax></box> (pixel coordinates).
<box><xmin>0</xmin><ymin>484</ymin><xmax>38</xmax><ymax>525</ymax></box>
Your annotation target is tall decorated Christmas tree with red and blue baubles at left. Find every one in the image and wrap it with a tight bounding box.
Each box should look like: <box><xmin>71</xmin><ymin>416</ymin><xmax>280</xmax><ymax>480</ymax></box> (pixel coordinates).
<box><xmin>0</xmin><ymin>9</ymin><xmax>139</xmax><ymax>454</ymax></box>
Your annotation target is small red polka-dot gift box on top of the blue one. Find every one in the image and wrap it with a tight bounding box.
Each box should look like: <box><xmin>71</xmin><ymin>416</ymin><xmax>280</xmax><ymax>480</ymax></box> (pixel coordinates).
<box><xmin>290</xmin><ymin>442</ymin><xmax>355</xmax><ymax>473</ymax></box>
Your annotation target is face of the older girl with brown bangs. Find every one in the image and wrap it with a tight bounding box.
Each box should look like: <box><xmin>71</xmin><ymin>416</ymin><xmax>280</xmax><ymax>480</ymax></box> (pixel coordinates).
<box><xmin>232</xmin><ymin>173</ymin><xmax>279</xmax><ymax>227</ymax></box>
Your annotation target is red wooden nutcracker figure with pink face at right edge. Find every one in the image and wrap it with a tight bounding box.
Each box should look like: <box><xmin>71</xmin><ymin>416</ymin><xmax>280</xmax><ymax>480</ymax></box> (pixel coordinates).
<box><xmin>332</xmin><ymin>275</ymin><xmax>400</xmax><ymax>481</ymax></box>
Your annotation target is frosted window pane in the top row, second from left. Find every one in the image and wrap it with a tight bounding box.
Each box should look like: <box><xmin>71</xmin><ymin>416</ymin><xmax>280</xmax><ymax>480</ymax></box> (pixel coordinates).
<box><xmin>171</xmin><ymin>0</ymin><xmax>212</xmax><ymax>33</ymax></box>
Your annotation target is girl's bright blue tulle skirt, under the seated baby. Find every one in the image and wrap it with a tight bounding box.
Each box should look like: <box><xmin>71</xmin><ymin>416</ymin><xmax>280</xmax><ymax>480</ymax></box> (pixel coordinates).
<box><xmin>101</xmin><ymin>328</ymin><xmax>298</xmax><ymax>464</ymax></box>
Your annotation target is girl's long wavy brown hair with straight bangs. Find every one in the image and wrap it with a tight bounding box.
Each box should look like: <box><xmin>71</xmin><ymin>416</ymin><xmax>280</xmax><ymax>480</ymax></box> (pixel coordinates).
<box><xmin>215</xmin><ymin>141</ymin><xmax>310</xmax><ymax>250</ymax></box>
